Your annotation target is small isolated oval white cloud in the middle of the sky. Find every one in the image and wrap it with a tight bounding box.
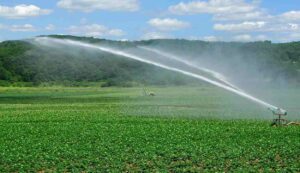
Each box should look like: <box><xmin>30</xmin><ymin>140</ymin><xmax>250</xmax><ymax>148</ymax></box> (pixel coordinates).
<box><xmin>148</xmin><ymin>18</ymin><xmax>190</xmax><ymax>31</ymax></box>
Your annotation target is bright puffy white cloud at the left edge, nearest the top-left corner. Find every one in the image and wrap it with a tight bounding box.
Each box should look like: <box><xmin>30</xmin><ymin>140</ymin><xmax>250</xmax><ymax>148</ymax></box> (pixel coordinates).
<box><xmin>0</xmin><ymin>4</ymin><xmax>51</xmax><ymax>19</ymax></box>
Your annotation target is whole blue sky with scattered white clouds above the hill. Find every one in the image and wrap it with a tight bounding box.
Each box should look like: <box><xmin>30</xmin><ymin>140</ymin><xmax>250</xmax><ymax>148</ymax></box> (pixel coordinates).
<box><xmin>0</xmin><ymin>0</ymin><xmax>300</xmax><ymax>42</ymax></box>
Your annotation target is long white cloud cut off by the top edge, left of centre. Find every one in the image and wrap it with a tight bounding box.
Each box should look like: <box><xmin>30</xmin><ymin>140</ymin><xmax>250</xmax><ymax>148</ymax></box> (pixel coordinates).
<box><xmin>57</xmin><ymin>0</ymin><xmax>139</xmax><ymax>12</ymax></box>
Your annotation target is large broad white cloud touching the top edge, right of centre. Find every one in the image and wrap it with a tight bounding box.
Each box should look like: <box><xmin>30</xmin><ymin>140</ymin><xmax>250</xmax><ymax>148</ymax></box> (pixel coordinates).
<box><xmin>169</xmin><ymin>0</ymin><xmax>272</xmax><ymax>21</ymax></box>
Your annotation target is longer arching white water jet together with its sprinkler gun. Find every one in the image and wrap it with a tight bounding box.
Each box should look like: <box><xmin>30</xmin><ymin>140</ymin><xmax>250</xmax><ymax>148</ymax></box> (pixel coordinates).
<box><xmin>35</xmin><ymin>37</ymin><xmax>287</xmax><ymax>122</ymax></box>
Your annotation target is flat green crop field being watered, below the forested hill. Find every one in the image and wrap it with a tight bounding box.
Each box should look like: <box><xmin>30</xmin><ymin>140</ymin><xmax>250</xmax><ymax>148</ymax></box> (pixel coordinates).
<box><xmin>0</xmin><ymin>87</ymin><xmax>300</xmax><ymax>172</ymax></box>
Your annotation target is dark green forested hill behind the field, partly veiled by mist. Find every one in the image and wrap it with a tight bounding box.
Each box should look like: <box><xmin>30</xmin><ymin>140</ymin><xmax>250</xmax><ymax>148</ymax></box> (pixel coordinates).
<box><xmin>0</xmin><ymin>35</ymin><xmax>300</xmax><ymax>86</ymax></box>
